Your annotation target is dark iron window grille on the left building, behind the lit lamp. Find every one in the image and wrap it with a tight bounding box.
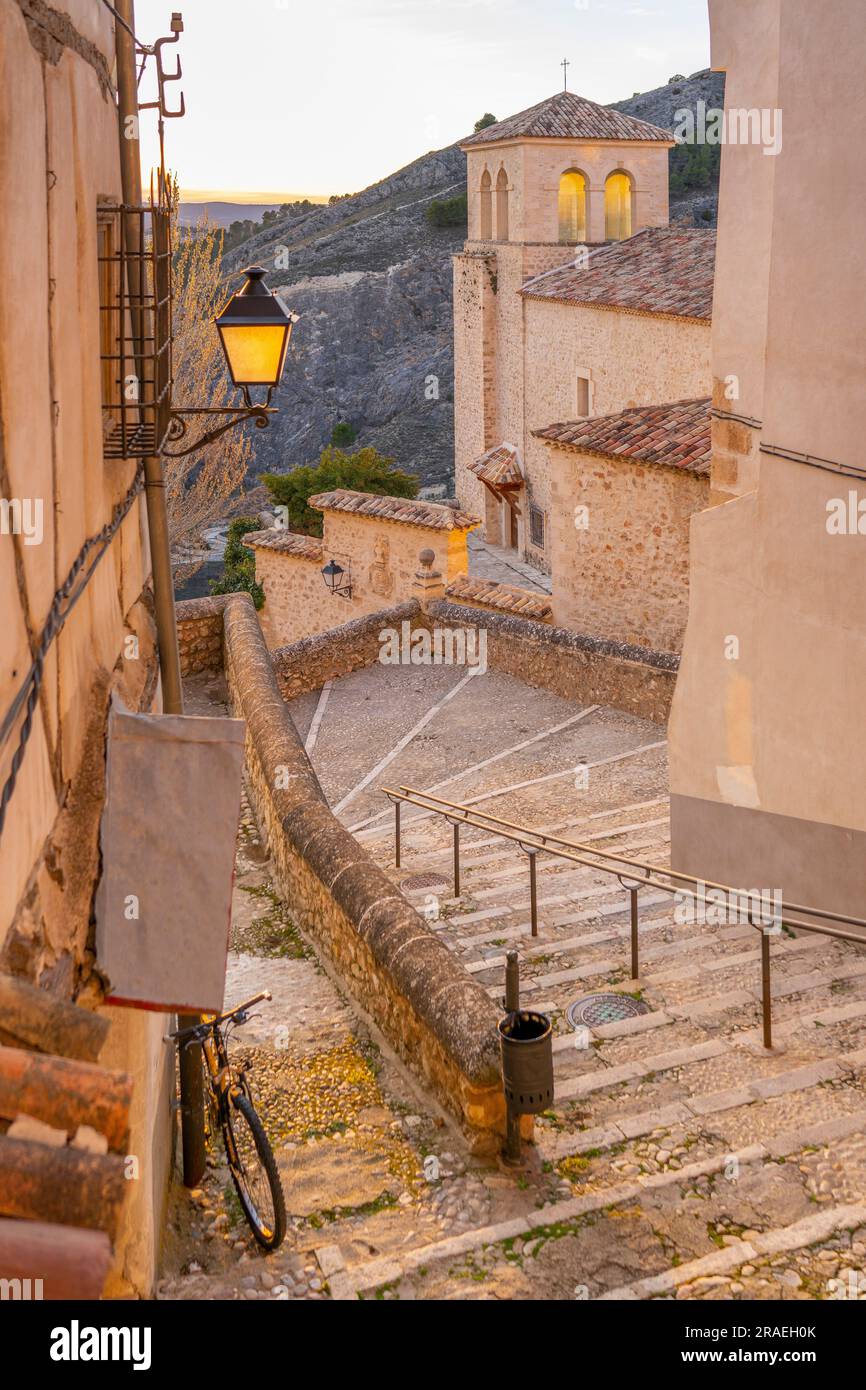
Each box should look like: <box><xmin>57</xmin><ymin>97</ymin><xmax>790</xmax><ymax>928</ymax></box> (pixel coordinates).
<box><xmin>97</xmin><ymin>204</ymin><xmax>172</xmax><ymax>459</ymax></box>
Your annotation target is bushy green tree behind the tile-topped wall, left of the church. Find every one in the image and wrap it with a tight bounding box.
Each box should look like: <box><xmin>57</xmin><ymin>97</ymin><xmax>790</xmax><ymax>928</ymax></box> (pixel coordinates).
<box><xmin>261</xmin><ymin>445</ymin><xmax>418</xmax><ymax>535</ymax></box>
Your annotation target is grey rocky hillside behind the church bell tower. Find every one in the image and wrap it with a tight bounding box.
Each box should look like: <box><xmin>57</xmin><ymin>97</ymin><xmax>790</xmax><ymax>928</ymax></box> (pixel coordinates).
<box><xmin>225</xmin><ymin>72</ymin><xmax>723</xmax><ymax>495</ymax></box>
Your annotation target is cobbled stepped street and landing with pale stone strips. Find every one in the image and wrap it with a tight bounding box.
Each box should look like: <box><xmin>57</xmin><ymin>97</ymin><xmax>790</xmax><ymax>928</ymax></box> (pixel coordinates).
<box><xmin>160</xmin><ymin>669</ymin><xmax>866</xmax><ymax>1301</ymax></box>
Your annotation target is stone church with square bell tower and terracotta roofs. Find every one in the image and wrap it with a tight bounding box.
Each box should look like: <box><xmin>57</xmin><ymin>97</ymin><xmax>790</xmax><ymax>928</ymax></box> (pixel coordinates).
<box><xmin>455</xmin><ymin>92</ymin><xmax>716</xmax><ymax>651</ymax></box>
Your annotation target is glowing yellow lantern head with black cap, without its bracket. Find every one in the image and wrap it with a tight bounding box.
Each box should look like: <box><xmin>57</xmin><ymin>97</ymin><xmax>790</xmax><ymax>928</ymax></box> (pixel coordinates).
<box><xmin>215</xmin><ymin>265</ymin><xmax>295</xmax><ymax>386</ymax></box>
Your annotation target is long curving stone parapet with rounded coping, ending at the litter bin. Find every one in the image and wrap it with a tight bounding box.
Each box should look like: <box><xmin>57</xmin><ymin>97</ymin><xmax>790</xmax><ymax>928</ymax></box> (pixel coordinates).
<box><xmin>224</xmin><ymin>595</ymin><xmax>505</xmax><ymax>1152</ymax></box>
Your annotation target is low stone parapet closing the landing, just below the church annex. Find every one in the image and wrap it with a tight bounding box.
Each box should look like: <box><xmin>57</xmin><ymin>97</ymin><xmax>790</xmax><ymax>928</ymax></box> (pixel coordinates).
<box><xmin>427</xmin><ymin>600</ymin><xmax>680</xmax><ymax>724</ymax></box>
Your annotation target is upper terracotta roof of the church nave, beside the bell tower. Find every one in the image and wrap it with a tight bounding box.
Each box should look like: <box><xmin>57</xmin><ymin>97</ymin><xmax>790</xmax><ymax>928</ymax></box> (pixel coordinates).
<box><xmin>520</xmin><ymin>227</ymin><xmax>716</xmax><ymax>320</ymax></box>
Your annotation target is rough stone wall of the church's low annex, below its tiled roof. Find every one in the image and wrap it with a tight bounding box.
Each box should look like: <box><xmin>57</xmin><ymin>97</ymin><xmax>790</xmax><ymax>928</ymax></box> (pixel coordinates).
<box><xmin>553</xmin><ymin>441</ymin><xmax>709</xmax><ymax>652</ymax></box>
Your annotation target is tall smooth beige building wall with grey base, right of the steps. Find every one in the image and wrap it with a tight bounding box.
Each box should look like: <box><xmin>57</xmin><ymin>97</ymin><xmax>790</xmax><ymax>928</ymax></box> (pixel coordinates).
<box><xmin>670</xmin><ymin>0</ymin><xmax>866</xmax><ymax>917</ymax></box>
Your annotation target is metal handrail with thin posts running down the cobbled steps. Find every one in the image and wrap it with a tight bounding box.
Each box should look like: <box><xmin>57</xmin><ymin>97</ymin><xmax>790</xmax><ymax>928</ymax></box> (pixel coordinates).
<box><xmin>382</xmin><ymin>785</ymin><xmax>866</xmax><ymax>1048</ymax></box>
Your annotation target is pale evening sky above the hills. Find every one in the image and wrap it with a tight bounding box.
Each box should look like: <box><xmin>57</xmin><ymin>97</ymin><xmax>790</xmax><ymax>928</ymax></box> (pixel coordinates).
<box><xmin>135</xmin><ymin>0</ymin><xmax>709</xmax><ymax>202</ymax></box>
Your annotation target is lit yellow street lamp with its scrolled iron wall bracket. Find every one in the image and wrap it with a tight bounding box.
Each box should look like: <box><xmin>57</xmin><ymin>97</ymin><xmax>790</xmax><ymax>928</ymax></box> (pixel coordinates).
<box><xmin>163</xmin><ymin>265</ymin><xmax>297</xmax><ymax>459</ymax></box>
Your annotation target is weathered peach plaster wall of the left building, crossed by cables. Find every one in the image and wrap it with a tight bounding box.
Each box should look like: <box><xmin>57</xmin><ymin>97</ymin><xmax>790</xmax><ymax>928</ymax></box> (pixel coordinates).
<box><xmin>0</xmin><ymin>0</ymin><xmax>171</xmax><ymax>1293</ymax></box>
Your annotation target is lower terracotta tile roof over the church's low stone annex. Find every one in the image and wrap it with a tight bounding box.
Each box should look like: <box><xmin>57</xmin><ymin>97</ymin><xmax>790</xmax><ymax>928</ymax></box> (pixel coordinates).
<box><xmin>532</xmin><ymin>396</ymin><xmax>710</xmax><ymax>477</ymax></box>
